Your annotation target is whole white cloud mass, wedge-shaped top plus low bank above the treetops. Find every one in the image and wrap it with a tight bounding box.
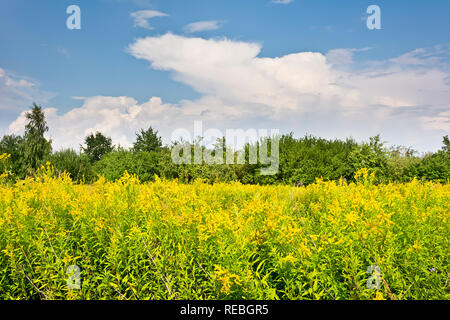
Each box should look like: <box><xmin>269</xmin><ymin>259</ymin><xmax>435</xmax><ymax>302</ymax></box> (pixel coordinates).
<box><xmin>10</xmin><ymin>33</ymin><xmax>450</xmax><ymax>151</ymax></box>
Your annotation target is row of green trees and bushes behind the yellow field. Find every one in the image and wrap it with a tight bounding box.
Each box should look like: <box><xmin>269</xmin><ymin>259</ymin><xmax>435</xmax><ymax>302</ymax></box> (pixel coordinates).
<box><xmin>0</xmin><ymin>104</ymin><xmax>450</xmax><ymax>185</ymax></box>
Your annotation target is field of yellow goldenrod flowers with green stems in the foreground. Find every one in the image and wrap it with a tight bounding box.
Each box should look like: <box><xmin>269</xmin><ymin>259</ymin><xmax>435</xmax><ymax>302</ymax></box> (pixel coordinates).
<box><xmin>0</xmin><ymin>160</ymin><xmax>450</xmax><ymax>299</ymax></box>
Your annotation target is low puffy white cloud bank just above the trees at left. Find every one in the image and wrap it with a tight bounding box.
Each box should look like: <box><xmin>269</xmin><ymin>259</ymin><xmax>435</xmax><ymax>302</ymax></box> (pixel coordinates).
<box><xmin>9</xmin><ymin>96</ymin><xmax>234</xmax><ymax>150</ymax></box>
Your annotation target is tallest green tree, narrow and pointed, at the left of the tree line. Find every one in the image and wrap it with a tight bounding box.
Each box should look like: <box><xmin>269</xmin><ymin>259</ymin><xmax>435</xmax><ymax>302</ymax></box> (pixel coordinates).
<box><xmin>24</xmin><ymin>103</ymin><xmax>52</xmax><ymax>169</ymax></box>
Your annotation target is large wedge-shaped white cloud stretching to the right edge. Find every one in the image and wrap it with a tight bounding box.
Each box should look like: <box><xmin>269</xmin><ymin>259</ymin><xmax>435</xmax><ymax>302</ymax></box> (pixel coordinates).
<box><xmin>125</xmin><ymin>33</ymin><xmax>450</xmax><ymax>149</ymax></box>
